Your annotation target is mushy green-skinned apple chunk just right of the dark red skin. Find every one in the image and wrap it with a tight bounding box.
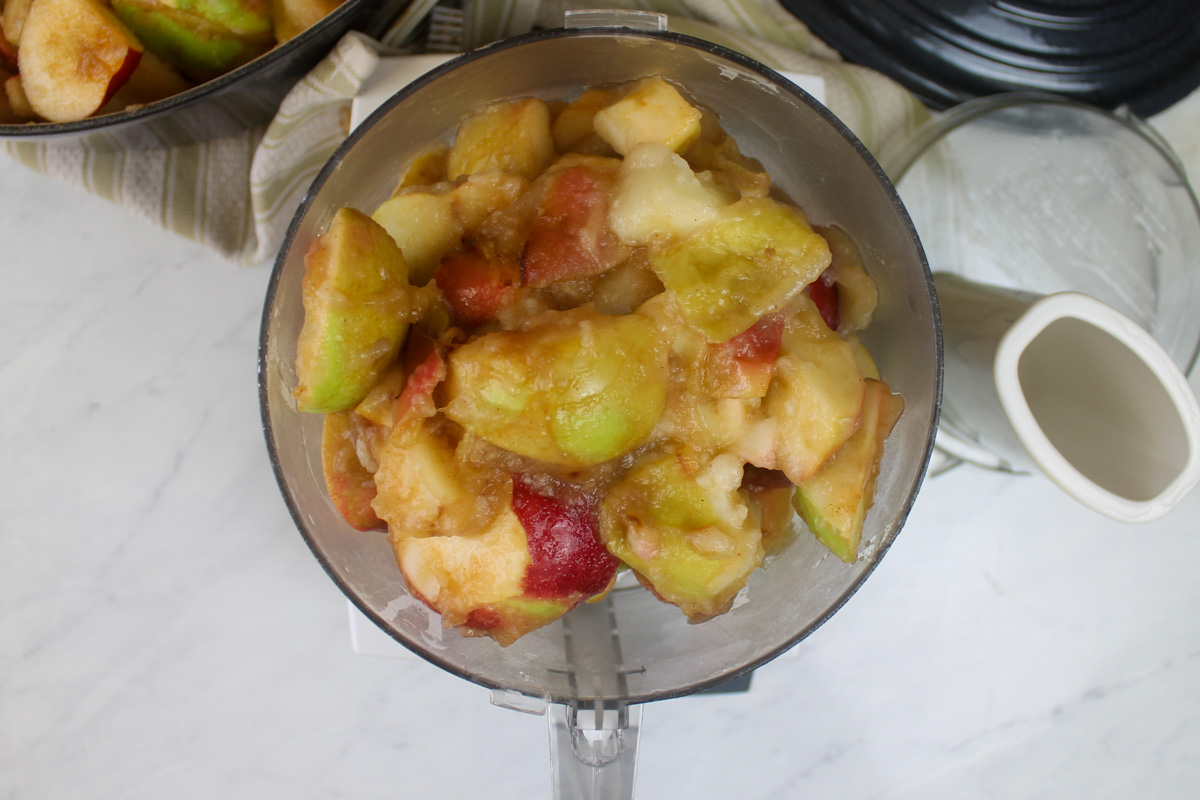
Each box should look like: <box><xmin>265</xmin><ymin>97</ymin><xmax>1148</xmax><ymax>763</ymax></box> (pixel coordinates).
<box><xmin>600</xmin><ymin>452</ymin><xmax>763</xmax><ymax>621</ymax></box>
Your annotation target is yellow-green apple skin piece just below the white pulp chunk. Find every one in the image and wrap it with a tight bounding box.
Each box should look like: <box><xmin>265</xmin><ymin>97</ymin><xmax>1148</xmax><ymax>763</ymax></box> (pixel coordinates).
<box><xmin>650</xmin><ymin>197</ymin><xmax>832</xmax><ymax>342</ymax></box>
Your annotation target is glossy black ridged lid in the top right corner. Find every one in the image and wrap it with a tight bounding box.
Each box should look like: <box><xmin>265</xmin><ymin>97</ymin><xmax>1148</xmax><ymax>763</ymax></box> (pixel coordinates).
<box><xmin>781</xmin><ymin>0</ymin><xmax>1200</xmax><ymax>116</ymax></box>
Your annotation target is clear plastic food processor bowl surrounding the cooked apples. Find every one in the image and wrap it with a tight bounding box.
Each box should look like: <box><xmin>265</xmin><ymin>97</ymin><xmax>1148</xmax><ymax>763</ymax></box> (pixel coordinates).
<box><xmin>259</xmin><ymin>21</ymin><xmax>942</xmax><ymax>796</ymax></box>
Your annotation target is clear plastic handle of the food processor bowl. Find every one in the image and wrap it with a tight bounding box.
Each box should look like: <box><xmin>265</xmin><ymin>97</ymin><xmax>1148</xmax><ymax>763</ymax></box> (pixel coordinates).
<box><xmin>546</xmin><ymin>703</ymin><xmax>642</xmax><ymax>800</ymax></box>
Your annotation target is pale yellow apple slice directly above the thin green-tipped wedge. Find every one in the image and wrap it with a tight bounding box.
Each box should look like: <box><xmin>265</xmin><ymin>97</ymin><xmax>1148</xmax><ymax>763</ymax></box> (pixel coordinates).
<box><xmin>737</xmin><ymin>297</ymin><xmax>865</xmax><ymax>483</ymax></box>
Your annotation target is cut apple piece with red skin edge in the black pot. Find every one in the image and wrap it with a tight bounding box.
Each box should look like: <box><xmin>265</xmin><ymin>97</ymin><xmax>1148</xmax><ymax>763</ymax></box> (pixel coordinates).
<box><xmin>18</xmin><ymin>0</ymin><xmax>144</xmax><ymax>122</ymax></box>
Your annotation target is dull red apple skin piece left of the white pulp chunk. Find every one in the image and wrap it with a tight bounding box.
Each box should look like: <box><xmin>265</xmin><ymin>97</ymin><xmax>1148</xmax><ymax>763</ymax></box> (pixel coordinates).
<box><xmin>521</xmin><ymin>164</ymin><xmax>624</xmax><ymax>288</ymax></box>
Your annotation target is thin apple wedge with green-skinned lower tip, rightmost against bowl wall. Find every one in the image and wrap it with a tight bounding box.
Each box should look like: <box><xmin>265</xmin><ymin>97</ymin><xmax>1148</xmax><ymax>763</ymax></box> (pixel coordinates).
<box><xmin>793</xmin><ymin>380</ymin><xmax>904</xmax><ymax>564</ymax></box>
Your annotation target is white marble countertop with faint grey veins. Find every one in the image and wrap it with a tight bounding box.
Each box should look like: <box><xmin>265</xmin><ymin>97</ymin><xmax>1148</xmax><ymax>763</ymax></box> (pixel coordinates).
<box><xmin>0</xmin><ymin>122</ymin><xmax>1200</xmax><ymax>800</ymax></box>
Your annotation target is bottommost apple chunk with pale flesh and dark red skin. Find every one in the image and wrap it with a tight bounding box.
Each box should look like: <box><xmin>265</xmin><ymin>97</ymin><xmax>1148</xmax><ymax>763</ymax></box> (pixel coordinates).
<box><xmin>394</xmin><ymin>475</ymin><xmax>618</xmax><ymax>645</ymax></box>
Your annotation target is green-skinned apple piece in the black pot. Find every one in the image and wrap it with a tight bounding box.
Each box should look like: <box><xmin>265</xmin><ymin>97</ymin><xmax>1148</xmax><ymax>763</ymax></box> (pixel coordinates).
<box><xmin>113</xmin><ymin>0</ymin><xmax>275</xmax><ymax>80</ymax></box>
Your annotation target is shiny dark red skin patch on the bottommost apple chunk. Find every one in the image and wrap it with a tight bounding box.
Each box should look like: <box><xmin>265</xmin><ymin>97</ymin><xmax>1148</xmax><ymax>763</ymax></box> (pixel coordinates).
<box><xmin>512</xmin><ymin>475</ymin><xmax>619</xmax><ymax>600</ymax></box>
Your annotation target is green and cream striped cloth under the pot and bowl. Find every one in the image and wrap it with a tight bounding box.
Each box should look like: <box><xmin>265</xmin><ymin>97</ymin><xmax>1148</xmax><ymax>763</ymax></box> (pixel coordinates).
<box><xmin>4</xmin><ymin>0</ymin><xmax>928</xmax><ymax>265</ymax></box>
